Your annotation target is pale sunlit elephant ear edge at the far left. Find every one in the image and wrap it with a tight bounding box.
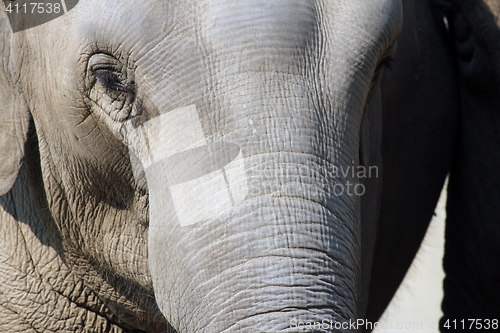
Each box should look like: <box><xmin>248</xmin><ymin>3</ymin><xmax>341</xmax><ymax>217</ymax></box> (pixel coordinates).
<box><xmin>0</xmin><ymin>9</ymin><xmax>30</xmax><ymax>196</ymax></box>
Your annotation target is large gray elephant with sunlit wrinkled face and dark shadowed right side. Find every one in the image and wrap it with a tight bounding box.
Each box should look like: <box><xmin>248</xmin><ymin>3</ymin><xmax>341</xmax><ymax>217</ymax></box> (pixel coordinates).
<box><xmin>0</xmin><ymin>0</ymin><xmax>458</xmax><ymax>333</ymax></box>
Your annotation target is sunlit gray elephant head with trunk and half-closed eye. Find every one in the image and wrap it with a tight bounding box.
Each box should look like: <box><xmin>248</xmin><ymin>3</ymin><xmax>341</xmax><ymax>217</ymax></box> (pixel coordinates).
<box><xmin>0</xmin><ymin>0</ymin><xmax>401</xmax><ymax>332</ymax></box>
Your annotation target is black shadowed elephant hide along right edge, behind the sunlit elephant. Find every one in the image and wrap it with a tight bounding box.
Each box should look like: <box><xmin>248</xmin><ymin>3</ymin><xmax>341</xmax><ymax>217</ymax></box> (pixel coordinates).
<box><xmin>434</xmin><ymin>0</ymin><xmax>500</xmax><ymax>331</ymax></box>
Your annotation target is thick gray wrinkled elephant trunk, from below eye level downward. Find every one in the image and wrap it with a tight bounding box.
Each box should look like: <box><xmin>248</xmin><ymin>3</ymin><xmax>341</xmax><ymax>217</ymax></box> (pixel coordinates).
<box><xmin>141</xmin><ymin>108</ymin><xmax>360</xmax><ymax>332</ymax></box>
